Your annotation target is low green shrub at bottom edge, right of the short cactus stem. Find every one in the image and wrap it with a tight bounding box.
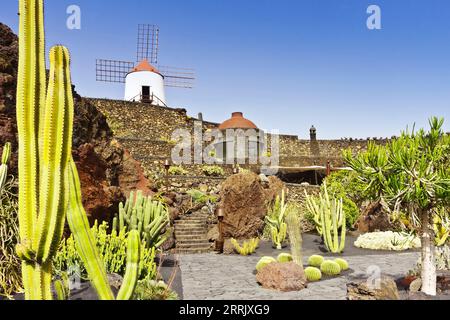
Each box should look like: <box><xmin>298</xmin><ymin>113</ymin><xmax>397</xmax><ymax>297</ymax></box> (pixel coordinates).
<box><xmin>133</xmin><ymin>279</ymin><xmax>178</xmax><ymax>300</ymax></box>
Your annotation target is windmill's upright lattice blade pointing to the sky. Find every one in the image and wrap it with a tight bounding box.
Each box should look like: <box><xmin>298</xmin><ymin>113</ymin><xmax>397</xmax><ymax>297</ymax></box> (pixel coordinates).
<box><xmin>136</xmin><ymin>24</ymin><xmax>159</xmax><ymax>64</ymax></box>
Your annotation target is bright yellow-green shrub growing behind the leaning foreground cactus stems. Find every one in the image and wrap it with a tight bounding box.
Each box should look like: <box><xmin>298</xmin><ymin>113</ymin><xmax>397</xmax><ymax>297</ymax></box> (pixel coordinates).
<box><xmin>53</xmin><ymin>222</ymin><xmax>157</xmax><ymax>280</ymax></box>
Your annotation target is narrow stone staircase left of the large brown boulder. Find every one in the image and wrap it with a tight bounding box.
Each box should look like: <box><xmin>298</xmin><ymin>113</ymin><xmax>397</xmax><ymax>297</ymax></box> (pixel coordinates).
<box><xmin>175</xmin><ymin>213</ymin><xmax>211</xmax><ymax>254</ymax></box>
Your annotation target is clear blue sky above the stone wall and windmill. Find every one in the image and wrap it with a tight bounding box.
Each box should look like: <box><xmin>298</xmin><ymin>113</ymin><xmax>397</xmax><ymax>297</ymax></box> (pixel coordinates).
<box><xmin>0</xmin><ymin>0</ymin><xmax>450</xmax><ymax>138</ymax></box>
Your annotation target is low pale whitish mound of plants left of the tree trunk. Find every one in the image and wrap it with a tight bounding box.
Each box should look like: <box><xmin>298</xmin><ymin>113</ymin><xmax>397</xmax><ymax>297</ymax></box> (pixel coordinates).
<box><xmin>354</xmin><ymin>231</ymin><xmax>421</xmax><ymax>251</ymax></box>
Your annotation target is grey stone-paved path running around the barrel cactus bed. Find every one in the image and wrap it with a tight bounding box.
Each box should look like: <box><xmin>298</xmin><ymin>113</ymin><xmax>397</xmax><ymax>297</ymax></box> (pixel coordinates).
<box><xmin>179</xmin><ymin>252</ymin><xmax>419</xmax><ymax>300</ymax></box>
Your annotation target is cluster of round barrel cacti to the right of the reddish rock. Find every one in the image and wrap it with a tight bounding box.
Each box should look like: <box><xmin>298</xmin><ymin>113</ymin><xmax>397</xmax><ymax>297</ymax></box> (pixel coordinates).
<box><xmin>305</xmin><ymin>255</ymin><xmax>349</xmax><ymax>281</ymax></box>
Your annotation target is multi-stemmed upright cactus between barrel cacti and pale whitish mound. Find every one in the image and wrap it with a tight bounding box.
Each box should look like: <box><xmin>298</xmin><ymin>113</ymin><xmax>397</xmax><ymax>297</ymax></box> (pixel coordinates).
<box><xmin>306</xmin><ymin>185</ymin><xmax>346</xmax><ymax>253</ymax></box>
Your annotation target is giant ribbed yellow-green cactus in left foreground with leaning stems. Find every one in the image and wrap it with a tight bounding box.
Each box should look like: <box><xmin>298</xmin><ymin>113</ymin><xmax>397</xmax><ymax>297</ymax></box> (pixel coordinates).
<box><xmin>16</xmin><ymin>0</ymin><xmax>140</xmax><ymax>300</ymax></box>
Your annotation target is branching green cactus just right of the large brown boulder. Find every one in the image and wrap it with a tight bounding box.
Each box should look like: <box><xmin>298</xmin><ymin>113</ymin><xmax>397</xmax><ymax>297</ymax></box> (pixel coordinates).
<box><xmin>265</xmin><ymin>190</ymin><xmax>297</xmax><ymax>250</ymax></box>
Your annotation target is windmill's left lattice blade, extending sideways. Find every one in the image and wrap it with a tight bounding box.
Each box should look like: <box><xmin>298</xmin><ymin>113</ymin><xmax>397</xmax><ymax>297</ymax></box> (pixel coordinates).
<box><xmin>95</xmin><ymin>59</ymin><xmax>134</xmax><ymax>83</ymax></box>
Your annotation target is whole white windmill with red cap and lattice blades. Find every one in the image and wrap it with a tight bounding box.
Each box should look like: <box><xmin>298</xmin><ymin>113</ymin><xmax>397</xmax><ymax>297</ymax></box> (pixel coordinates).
<box><xmin>96</xmin><ymin>24</ymin><xmax>195</xmax><ymax>106</ymax></box>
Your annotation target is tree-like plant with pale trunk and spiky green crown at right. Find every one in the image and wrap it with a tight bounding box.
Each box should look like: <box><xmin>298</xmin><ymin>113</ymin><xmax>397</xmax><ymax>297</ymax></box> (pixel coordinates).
<box><xmin>344</xmin><ymin>117</ymin><xmax>450</xmax><ymax>295</ymax></box>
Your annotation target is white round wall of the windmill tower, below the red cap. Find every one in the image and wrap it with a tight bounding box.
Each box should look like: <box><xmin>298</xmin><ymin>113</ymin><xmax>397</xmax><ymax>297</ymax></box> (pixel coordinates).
<box><xmin>124</xmin><ymin>71</ymin><xmax>166</xmax><ymax>106</ymax></box>
